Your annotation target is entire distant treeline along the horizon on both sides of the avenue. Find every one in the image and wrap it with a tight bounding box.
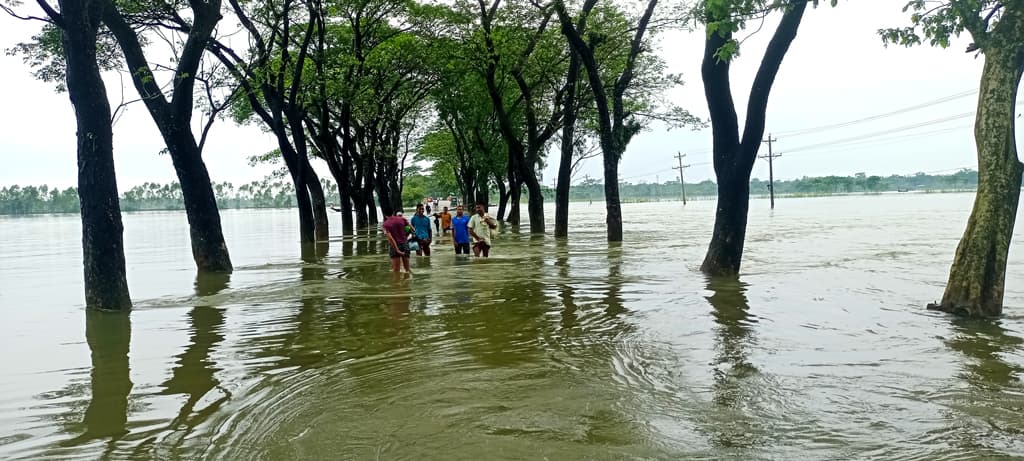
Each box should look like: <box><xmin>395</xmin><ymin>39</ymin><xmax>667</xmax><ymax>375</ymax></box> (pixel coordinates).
<box><xmin>0</xmin><ymin>170</ymin><xmax>978</xmax><ymax>214</ymax></box>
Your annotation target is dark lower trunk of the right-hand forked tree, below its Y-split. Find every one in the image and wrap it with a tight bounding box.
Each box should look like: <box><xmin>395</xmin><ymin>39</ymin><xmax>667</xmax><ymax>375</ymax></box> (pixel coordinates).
<box><xmin>700</xmin><ymin>169</ymin><xmax>751</xmax><ymax>276</ymax></box>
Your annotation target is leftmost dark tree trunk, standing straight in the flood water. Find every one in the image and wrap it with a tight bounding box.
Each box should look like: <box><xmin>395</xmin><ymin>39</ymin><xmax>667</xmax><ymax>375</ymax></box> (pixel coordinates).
<box><xmin>59</xmin><ymin>0</ymin><xmax>131</xmax><ymax>309</ymax></box>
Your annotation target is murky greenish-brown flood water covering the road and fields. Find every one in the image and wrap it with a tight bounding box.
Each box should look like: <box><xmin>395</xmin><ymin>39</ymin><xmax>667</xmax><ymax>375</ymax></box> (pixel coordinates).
<box><xmin>0</xmin><ymin>194</ymin><xmax>1024</xmax><ymax>460</ymax></box>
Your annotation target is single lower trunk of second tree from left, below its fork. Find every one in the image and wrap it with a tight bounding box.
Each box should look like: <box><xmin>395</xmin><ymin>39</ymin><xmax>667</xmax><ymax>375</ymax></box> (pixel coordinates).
<box><xmin>158</xmin><ymin>128</ymin><xmax>232</xmax><ymax>273</ymax></box>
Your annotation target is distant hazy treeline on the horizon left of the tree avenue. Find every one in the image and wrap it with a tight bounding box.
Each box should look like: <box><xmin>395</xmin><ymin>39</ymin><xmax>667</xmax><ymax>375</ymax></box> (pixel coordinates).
<box><xmin>0</xmin><ymin>177</ymin><xmax>338</xmax><ymax>214</ymax></box>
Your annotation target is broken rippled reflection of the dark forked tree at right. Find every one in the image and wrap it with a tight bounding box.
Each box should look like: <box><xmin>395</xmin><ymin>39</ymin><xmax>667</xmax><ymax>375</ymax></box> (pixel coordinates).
<box><xmin>707</xmin><ymin>277</ymin><xmax>761</xmax><ymax>448</ymax></box>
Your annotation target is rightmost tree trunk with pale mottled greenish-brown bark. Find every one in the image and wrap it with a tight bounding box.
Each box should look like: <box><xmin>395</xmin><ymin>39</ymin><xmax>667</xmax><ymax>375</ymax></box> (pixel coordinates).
<box><xmin>929</xmin><ymin>45</ymin><xmax>1024</xmax><ymax>318</ymax></box>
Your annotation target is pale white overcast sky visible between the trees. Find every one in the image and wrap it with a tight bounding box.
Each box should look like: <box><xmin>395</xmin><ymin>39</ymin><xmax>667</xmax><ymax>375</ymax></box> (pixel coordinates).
<box><xmin>0</xmin><ymin>0</ymin><xmax>995</xmax><ymax>190</ymax></box>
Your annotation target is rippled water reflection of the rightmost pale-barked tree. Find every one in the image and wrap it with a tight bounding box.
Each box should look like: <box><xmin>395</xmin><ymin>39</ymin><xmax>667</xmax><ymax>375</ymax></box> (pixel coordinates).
<box><xmin>946</xmin><ymin>319</ymin><xmax>1024</xmax><ymax>446</ymax></box>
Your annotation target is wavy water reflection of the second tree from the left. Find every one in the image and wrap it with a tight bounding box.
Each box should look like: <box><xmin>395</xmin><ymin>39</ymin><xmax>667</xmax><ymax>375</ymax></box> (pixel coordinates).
<box><xmin>160</xmin><ymin>274</ymin><xmax>230</xmax><ymax>439</ymax></box>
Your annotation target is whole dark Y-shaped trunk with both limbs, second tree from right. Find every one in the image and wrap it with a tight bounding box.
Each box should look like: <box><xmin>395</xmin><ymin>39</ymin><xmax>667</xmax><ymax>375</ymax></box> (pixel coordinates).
<box><xmin>700</xmin><ymin>0</ymin><xmax>808</xmax><ymax>276</ymax></box>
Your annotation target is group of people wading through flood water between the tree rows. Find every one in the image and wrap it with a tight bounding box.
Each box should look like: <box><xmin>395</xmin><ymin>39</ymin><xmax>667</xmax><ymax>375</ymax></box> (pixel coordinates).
<box><xmin>383</xmin><ymin>203</ymin><xmax>498</xmax><ymax>274</ymax></box>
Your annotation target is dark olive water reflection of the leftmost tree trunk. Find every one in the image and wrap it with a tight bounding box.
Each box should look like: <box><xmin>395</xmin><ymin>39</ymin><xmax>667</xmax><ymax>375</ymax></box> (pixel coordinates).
<box><xmin>61</xmin><ymin>309</ymin><xmax>132</xmax><ymax>449</ymax></box>
